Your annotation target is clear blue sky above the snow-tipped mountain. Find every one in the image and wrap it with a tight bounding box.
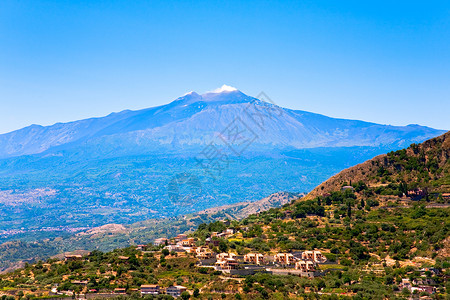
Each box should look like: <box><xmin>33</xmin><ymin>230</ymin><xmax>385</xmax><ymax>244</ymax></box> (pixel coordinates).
<box><xmin>0</xmin><ymin>0</ymin><xmax>450</xmax><ymax>133</ymax></box>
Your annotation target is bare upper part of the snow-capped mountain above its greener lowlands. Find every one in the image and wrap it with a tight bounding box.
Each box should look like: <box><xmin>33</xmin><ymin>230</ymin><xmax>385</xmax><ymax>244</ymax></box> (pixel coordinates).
<box><xmin>0</xmin><ymin>86</ymin><xmax>444</xmax><ymax>158</ymax></box>
